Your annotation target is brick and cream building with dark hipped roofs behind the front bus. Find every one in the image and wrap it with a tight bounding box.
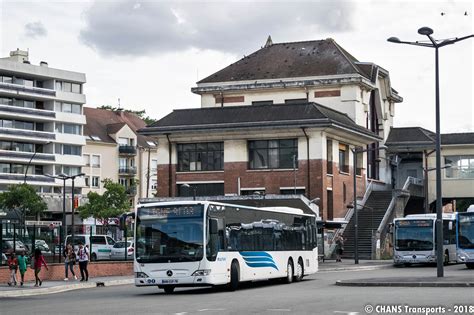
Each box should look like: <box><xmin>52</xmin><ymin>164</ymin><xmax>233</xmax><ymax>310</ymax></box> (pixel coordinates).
<box><xmin>141</xmin><ymin>38</ymin><xmax>402</xmax><ymax>219</ymax></box>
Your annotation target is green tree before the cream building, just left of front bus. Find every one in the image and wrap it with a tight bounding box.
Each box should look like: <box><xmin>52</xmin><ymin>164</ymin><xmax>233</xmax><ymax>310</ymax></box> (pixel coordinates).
<box><xmin>77</xmin><ymin>179</ymin><xmax>130</xmax><ymax>228</ymax></box>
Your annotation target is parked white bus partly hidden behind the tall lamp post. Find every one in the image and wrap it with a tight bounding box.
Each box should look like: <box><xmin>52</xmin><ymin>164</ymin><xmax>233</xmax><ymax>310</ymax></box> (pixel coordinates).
<box><xmin>393</xmin><ymin>213</ymin><xmax>457</xmax><ymax>266</ymax></box>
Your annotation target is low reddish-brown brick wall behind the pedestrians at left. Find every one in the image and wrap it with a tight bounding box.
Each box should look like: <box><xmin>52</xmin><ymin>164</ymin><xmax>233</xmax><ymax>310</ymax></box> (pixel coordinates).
<box><xmin>0</xmin><ymin>261</ymin><xmax>133</xmax><ymax>283</ymax></box>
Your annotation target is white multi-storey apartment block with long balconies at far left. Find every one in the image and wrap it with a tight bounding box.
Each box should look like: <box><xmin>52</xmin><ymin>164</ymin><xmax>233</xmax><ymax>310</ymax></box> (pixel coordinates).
<box><xmin>0</xmin><ymin>49</ymin><xmax>86</xmax><ymax>219</ymax></box>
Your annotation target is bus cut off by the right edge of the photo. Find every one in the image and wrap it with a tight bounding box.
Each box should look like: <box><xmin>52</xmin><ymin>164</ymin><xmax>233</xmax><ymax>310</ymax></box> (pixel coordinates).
<box><xmin>456</xmin><ymin>205</ymin><xmax>474</xmax><ymax>269</ymax></box>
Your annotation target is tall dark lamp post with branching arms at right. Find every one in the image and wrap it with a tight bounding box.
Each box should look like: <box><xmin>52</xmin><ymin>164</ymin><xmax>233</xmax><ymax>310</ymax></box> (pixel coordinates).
<box><xmin>387</xmin><ymin>27</ymin><xmax>474</xmax><ymax>278</ymax></box>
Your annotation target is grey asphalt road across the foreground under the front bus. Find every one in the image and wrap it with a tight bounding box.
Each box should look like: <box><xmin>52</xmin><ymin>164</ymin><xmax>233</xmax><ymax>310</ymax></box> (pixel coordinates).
<box><xmin>0</xmin><ymin>265</ymin><xmax>474</xmax><ymax>315</ymax></box>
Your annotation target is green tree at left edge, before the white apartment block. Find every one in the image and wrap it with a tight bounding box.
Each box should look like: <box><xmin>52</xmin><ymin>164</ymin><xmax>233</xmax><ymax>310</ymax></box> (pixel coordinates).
<box><xmin>0</xmin><ymin>183</ymin><xmax>48</xmax><ymax>218</ymax></box>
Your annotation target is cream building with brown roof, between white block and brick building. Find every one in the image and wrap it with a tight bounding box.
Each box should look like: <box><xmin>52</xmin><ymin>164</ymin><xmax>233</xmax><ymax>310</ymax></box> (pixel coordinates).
<box><xmin>82</xmin><ymin>107</ymin><xmax>158</xmax><ymax>209</ymax></box>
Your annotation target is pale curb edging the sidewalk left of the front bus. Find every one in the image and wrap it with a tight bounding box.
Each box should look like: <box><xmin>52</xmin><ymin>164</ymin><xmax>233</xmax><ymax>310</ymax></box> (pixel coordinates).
<box><xmin>0</xmin><ymin>279</ymin><xmax>134</xmax><ymax>298</ymax></box>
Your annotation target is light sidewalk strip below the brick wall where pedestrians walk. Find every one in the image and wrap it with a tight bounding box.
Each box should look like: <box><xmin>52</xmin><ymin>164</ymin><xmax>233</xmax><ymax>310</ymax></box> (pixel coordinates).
<box><xmin>0</xmin><ymin>276</ymin><xmax>134</xmax><ymax>298</ymax></box>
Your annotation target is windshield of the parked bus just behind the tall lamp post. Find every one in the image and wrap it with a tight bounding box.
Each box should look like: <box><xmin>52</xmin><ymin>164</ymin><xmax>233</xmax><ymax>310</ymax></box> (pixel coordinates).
<box><xmin>395</xmin><ymin>220</ymin><xmax>433</xmax><ymax>251</ymax></box>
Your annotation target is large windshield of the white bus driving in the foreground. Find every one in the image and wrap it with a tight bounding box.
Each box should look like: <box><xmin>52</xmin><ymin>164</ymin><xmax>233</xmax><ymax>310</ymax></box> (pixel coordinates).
<box><xmin>136</xmin><ymin>205</ymin><xmax>204</xmax><ymax>263</ymax></box>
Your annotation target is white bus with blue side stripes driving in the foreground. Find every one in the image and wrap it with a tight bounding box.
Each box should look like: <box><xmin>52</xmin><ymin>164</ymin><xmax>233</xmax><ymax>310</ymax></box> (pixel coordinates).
<box><xmin>134</xmin><ymin>201</ymin><xmax>318</xmax><ymax>293</ymax></box>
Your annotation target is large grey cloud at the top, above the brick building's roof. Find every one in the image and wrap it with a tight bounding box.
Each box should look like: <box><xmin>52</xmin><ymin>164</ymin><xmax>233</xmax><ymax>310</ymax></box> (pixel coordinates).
<box><xmin>79</xmin><ymin>0</ymin><xmax>355</xmax><ymax>56</ymax></box>
